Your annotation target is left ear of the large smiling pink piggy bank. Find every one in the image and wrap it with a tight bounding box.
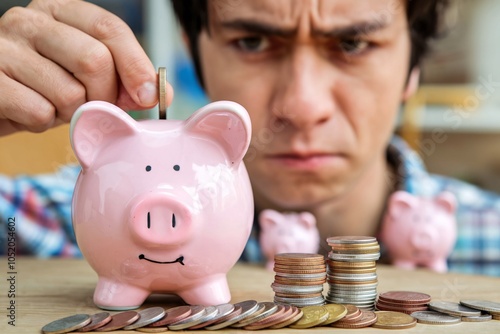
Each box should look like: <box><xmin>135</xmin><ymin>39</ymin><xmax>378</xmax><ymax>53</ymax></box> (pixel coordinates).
<box><xmin>70</xmin><ymin>101</ymin><xmax>137</xmax><ymax>169</ymax></box>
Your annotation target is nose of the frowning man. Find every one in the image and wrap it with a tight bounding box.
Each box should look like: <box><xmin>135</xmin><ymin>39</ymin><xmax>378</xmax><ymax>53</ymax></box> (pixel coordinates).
<box><xmin>272</xmin><ymin>45</ymin><xmax>334</xmax><ymax>130</ymax></box>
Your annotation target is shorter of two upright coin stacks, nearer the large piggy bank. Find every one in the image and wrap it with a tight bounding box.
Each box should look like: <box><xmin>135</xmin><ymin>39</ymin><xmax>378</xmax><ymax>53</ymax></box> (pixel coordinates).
<box><xmin>271</xmin><ymin>253</ymin><xmax>326</xmax><ymax>307</ymax></box>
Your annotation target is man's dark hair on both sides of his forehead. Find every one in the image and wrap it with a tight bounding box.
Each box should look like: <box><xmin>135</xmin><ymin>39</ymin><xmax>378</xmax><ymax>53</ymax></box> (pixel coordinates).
<box><xmin>171</xmin><ymin>0</ymin><xmax>448</xmax><ymax>85</ymax></box>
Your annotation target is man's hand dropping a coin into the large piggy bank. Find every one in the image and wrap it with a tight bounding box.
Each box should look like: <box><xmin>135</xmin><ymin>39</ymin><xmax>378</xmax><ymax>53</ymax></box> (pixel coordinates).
<box><xmin>0</xmin><ymin>0</ymin><xmax>173</xmax><ymax>135</ymax></box>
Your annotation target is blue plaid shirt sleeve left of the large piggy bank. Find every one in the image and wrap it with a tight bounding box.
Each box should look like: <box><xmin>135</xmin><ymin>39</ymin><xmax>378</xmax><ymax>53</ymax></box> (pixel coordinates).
<box><xmin>0</xmin><ymin>166</ymin><xmax>81</xmax><ymax>257</ymax></box>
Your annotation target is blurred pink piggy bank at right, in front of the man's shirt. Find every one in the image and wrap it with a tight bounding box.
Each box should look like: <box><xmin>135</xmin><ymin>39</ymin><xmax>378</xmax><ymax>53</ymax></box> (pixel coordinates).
<box><xmin>380</xmin><ymin>191</ymin><xmax>457</xmax><ymax>272</ymax></box>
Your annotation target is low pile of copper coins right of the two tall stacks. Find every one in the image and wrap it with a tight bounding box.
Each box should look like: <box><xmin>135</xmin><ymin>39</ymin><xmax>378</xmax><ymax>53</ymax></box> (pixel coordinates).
<box><xmin>375</xmin><ymin>291</ymin><xmax>431</xmax><ymax>314</ymax></box>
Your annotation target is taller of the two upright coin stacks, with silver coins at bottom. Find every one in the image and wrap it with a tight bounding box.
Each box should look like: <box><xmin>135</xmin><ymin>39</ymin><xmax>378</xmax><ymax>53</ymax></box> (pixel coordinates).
<box><xmin>326</xmin><ymin>236</ymin><xmax>380</xmax><ymax>310</ymax></box>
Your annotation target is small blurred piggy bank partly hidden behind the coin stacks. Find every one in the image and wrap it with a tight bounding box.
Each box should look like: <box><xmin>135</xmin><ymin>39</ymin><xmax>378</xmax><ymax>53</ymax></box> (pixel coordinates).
<box><xmin>259</xmin><ymin>209</ymin><xmax>319</xmax><ymax>270</ymax></box>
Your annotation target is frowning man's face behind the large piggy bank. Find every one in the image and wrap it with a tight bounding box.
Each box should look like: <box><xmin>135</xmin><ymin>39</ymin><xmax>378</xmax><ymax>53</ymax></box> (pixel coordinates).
<box><xmin>200</xmin><ymin>0</ymin><xmax>410</xmax><ymax>209</ymax></box>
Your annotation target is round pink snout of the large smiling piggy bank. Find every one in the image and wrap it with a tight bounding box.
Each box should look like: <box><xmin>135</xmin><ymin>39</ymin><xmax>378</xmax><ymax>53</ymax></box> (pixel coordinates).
<box><xmin>131</xmin><ymin>193</ymin><xmax>192</xmax><ymax>246</ymax></box>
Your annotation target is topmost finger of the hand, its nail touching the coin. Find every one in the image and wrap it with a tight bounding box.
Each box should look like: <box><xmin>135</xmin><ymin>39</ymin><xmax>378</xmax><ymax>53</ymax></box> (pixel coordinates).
<box><xmin>52</xmin><ymin>1</ymin><xmax>158</xmax><ymax>108</ymax></box>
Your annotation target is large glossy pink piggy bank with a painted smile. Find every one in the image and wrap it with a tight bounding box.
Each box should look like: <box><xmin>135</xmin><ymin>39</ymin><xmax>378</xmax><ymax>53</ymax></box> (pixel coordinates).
<box><xmin>71</xmin><ymin>101</ymin><xmax>254</xmax><ymax>310</ymax></box>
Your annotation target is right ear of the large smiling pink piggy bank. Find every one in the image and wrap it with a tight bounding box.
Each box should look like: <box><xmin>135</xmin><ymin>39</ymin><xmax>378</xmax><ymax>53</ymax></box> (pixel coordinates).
<box><xmin>185</xmin><ymin>101</ymin><xmax>252</xmax><ymax>167</ymax></box>
